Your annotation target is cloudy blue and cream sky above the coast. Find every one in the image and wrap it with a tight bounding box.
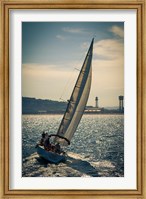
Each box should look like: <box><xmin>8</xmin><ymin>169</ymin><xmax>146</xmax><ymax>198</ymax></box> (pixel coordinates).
<box><xmin>22</xmin><ymin>22</ymin><xmax>124</xmax><ymax>107</ymax></box>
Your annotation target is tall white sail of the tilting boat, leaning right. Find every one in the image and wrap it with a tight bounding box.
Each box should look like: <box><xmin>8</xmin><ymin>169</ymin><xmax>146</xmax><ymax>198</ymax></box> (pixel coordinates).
<box><xmin>55</xmin><ymin>39</ymin><xmax>94</xmax><ymax>145</ymax></box>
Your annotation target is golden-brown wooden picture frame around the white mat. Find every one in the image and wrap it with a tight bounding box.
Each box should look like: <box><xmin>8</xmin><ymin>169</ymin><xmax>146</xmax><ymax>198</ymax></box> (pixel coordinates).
<box><xmin>0</xmin><ymin>0</ymin><xmax>146</xmax><ymax>199</ymax></box>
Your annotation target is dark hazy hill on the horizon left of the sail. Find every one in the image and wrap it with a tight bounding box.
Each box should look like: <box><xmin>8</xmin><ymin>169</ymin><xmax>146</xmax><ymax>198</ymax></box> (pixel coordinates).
<box><xmin>22</xmin><ymin>97</ymin><xmax>67</xmax><ymax>114</ymax></box>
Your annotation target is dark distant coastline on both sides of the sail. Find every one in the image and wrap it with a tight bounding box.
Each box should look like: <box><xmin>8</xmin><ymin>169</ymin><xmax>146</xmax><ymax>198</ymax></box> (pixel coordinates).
<box><xmin>22</xmin><ymin>97</ymin><xmax>124</xmax><ymax>115</ymax></box>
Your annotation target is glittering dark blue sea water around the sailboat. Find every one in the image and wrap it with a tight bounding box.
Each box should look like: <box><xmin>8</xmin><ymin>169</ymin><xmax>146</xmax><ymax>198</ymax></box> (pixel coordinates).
<box><xmin>22</xmin><ymin>114</ymin><xmax>124</xmax><ymax>177</ymax></box>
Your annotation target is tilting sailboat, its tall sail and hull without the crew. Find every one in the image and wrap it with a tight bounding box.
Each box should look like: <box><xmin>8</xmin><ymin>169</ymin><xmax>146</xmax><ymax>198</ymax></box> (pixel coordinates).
<box><xmin>36</xmin><ymin>38</ymin><xmax>94</xmax><ymax>163</ymax></box>
